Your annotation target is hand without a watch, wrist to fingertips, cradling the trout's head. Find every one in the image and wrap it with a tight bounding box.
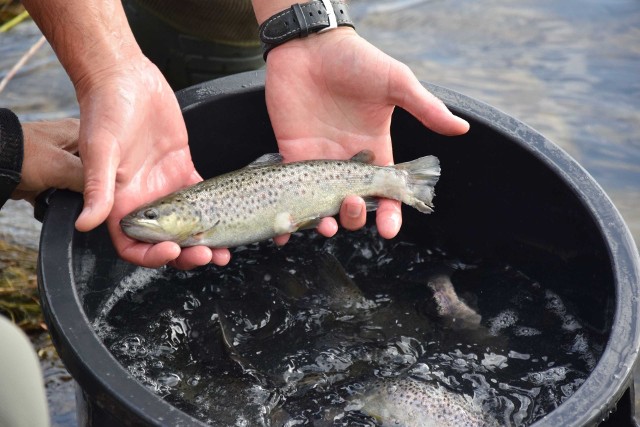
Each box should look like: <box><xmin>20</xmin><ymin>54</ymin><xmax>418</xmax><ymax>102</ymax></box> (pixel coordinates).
<box><xmin>76</xmin><ymin>55</ymin><xmax>230</xmax><ymax>269</ymax></box>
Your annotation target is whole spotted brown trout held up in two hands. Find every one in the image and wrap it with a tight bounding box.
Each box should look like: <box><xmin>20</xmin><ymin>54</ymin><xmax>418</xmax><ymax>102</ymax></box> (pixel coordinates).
<box><xmin>120</xmin><ymin>150</ymin><xmax>440</xmax><ymax>248</ymax></box>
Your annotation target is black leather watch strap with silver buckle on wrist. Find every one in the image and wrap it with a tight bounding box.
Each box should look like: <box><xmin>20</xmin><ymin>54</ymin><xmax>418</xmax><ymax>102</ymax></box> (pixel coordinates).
<box><xmin>260</xmin><ymin>0</ymin><xmax>355</xmax><ymax>60</ymax></box>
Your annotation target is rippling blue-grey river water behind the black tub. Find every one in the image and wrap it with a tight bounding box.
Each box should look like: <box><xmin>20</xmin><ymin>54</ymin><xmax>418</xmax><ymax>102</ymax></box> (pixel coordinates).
<box><xmin>0</xmin><ymin>0</ymin><xmax>640</xmax><ymax>424</ymax></box>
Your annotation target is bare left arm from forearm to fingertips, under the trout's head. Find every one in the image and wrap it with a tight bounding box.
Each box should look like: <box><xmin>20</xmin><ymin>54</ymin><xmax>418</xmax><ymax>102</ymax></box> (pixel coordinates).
<box><xmin>23</xmin><ymin>0</ymin><xmax>229</xmax><ymax>268</ymax></box>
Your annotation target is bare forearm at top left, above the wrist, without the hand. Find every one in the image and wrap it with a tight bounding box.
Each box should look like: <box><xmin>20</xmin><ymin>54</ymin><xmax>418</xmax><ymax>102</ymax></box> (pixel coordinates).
<box><xmin>23</xmin><ymin>0</ymin><xmax>141</xmax><ymax>85</ymax></box>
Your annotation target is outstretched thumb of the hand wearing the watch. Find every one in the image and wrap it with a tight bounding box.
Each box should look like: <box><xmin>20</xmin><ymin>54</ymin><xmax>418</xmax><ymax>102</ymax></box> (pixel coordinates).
<box><xmin>389</xmin><ymin>62</ymin><xmax>469</xmax><ymax>136</ymax></box>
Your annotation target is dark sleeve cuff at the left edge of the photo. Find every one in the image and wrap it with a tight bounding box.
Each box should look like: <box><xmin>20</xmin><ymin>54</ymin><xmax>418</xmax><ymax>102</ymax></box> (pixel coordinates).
<box><xmin>0</xmin><ymin>108</ymin><xmax>24</xmax><ymax>208</ymax></box>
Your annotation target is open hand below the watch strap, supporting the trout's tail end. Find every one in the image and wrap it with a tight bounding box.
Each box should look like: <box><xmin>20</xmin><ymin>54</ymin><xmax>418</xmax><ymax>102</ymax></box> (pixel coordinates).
<box><xmin>265</xmin><ymin>27</ymin><xmax>469</xmax><ymax>243</ymax></box>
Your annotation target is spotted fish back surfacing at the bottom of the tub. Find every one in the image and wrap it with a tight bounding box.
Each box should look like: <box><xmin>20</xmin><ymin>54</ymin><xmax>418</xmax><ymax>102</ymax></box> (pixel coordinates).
<box><xmin>352</xmin><ymin>377</ymin><xmax>490</xmax><ymax>427</ymax></box>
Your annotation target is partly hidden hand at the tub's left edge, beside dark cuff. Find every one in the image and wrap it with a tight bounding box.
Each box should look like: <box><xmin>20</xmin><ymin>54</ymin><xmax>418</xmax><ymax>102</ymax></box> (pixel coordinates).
<box><xmin>11</xmin><ymin>119</ymin><xmax>83</xmax><ymax>204</ymax></box>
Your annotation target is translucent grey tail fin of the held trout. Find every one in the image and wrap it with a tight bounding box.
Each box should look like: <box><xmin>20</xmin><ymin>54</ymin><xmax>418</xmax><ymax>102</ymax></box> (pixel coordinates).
<box><xmin>394</xmin><ymin>156</ymin><xmax>440</xmax><ymax>213</ymax></box>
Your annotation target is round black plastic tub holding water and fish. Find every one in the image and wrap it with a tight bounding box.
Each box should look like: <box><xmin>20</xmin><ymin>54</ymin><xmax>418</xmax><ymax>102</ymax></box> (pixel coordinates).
<box><xmin>38</xmin><ymin>72</ymin><xmax>640</xmax><ymax>427</ymax></box>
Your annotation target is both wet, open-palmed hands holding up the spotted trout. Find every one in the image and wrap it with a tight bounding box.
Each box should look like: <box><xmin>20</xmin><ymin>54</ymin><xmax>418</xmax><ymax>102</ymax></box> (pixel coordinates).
<box><xmin>50</xmin><ymin>28</ymin><xmax>468</xmax><ymax>269</ymax></box>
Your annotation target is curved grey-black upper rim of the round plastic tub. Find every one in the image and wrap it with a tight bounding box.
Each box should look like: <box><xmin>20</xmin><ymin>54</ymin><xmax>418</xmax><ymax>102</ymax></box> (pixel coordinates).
<box><xmin>38</xmin><ymin>70</ymin><xmax>640</xmax><ymax>427</ymax></box>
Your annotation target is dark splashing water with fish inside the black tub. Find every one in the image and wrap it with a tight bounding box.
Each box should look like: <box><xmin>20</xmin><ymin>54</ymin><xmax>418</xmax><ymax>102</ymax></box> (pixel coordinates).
<box><xmin>94</xmin><ymin>228</ymin><xmax>607</xmax><ymax>427</ymax></box>
